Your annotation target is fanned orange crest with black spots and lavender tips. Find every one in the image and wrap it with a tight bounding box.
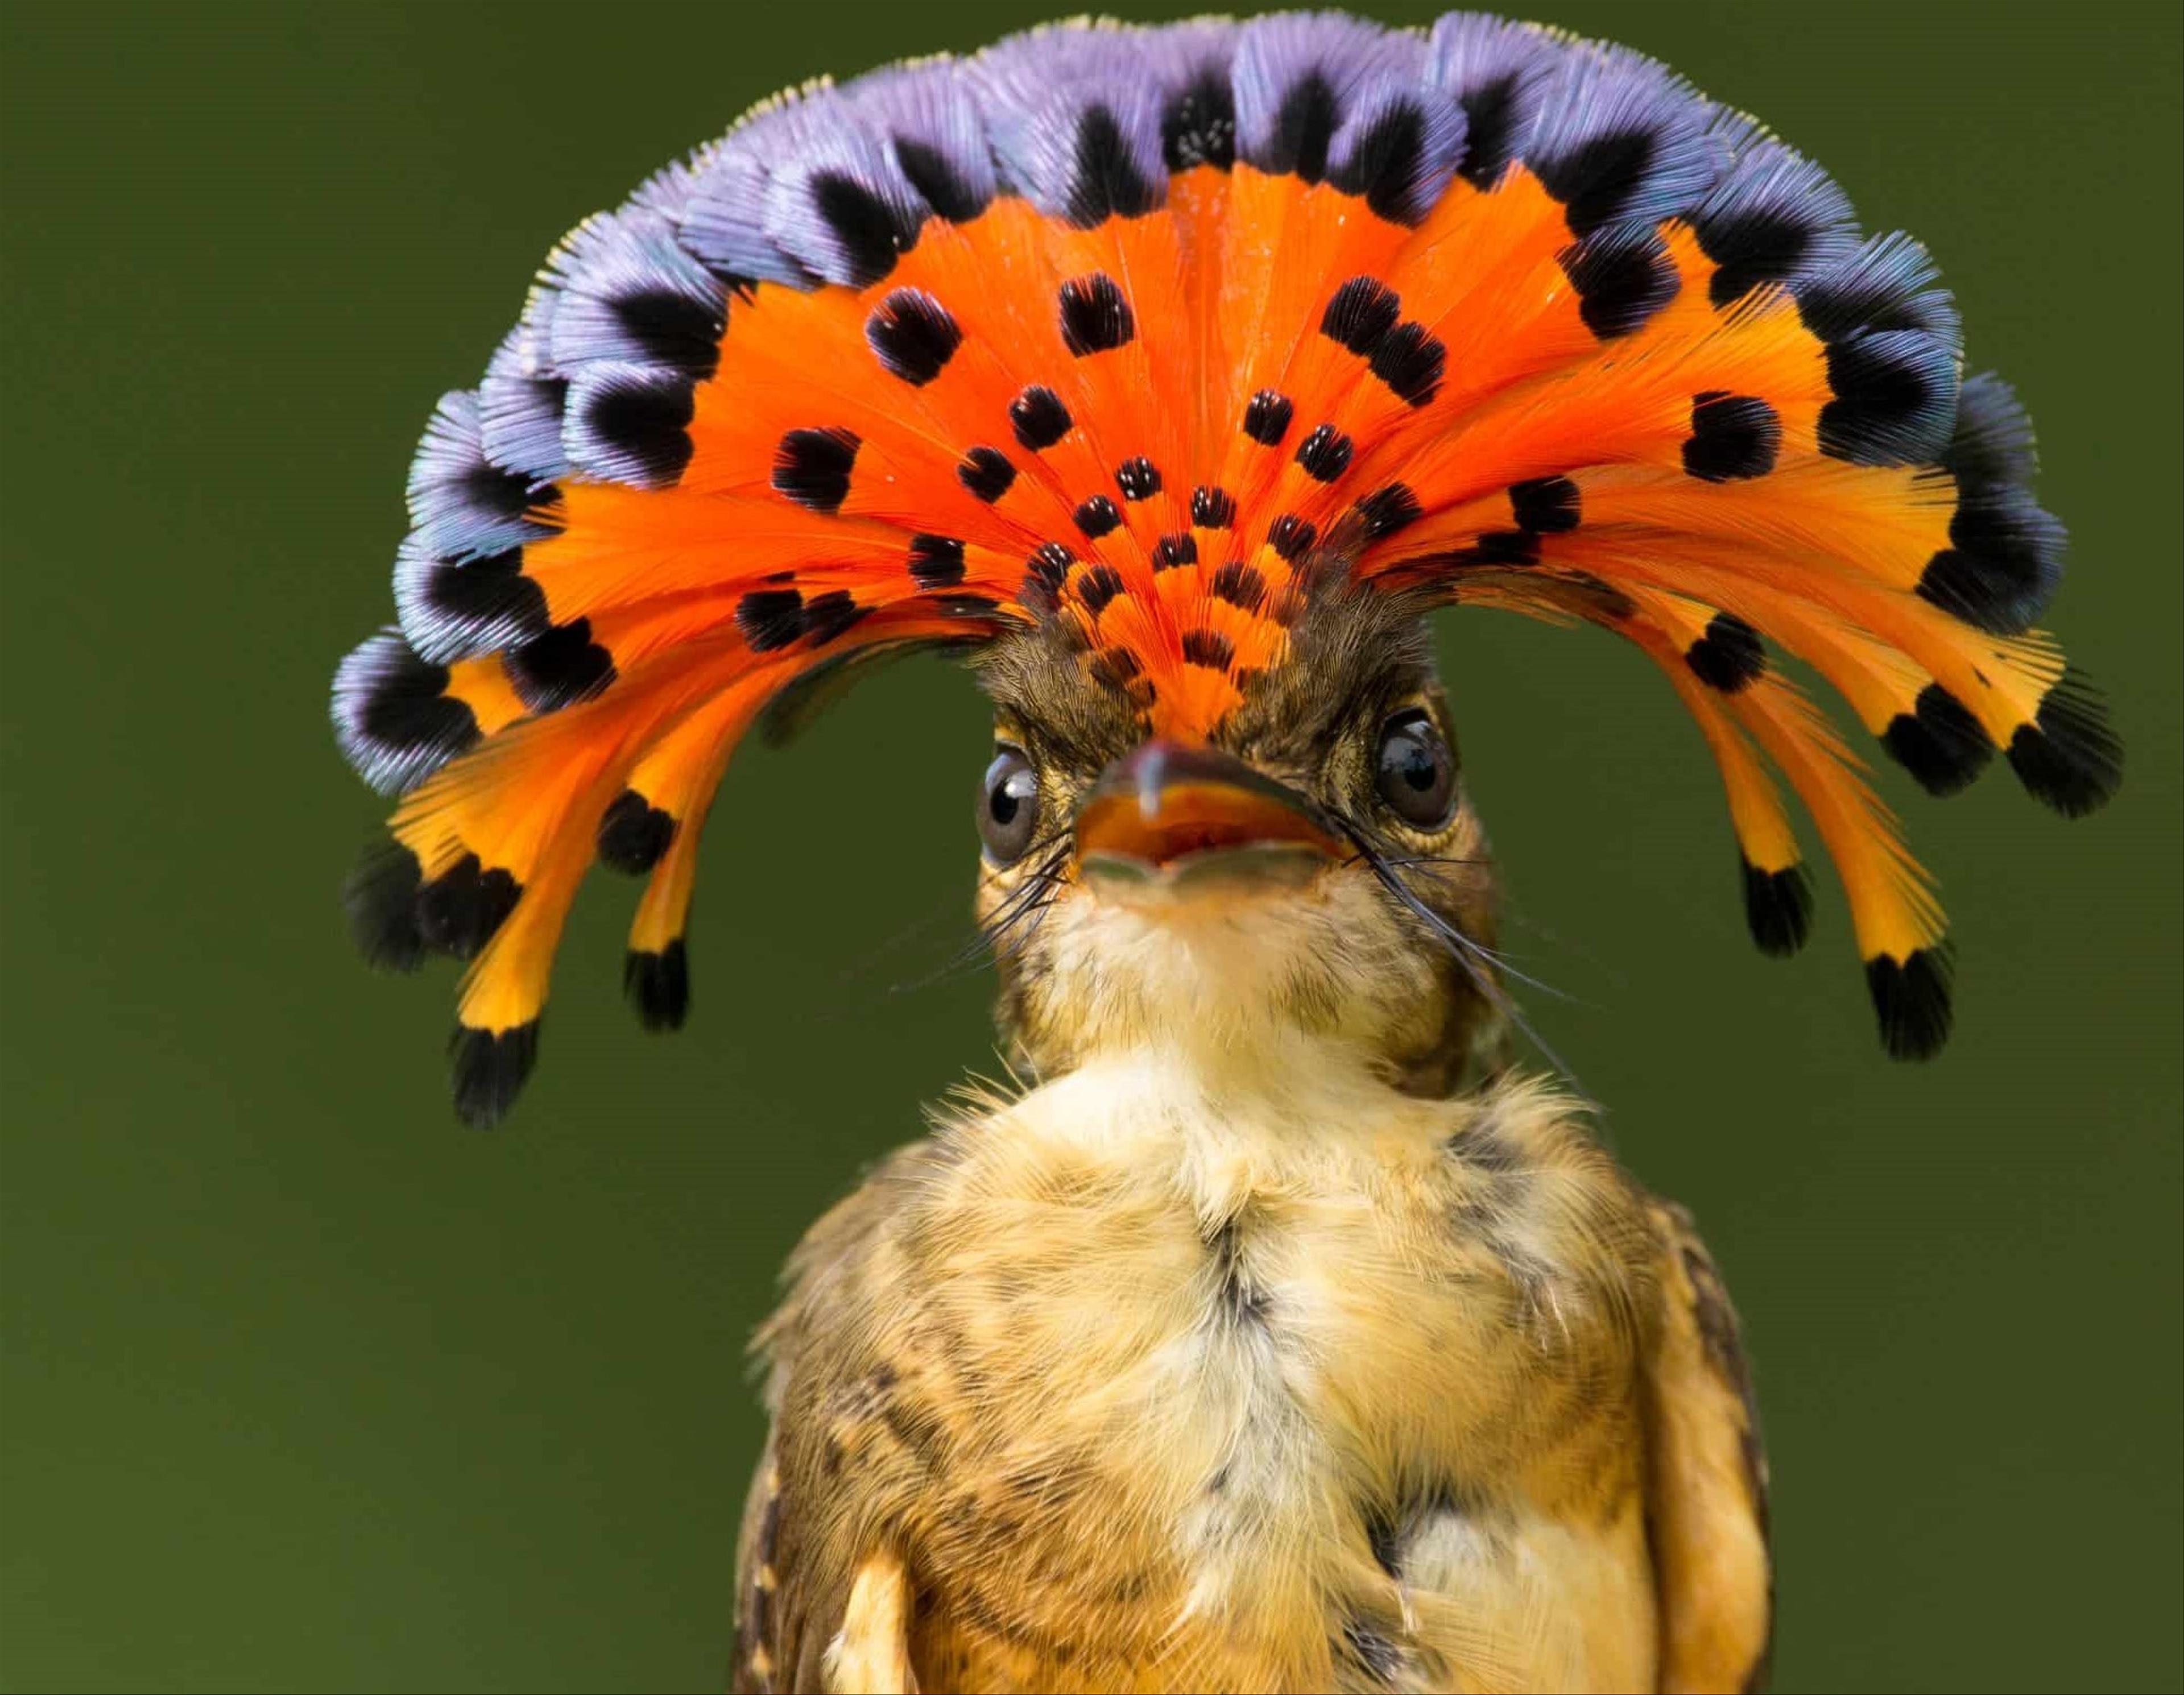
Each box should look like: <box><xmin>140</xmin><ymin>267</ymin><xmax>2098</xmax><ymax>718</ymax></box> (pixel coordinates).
<box><xmin>334</xmin><ymin>13</ymin><xmax>2119</xmax><ymax>1123</ymax></box>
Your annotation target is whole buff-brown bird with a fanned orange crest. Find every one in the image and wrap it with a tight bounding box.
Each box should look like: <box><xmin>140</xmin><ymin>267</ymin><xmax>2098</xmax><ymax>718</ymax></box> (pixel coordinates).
<box><xmin>332</xmin><ymin>13</ymin><xmax>2121</xmax><ymax>1690</ymax></box>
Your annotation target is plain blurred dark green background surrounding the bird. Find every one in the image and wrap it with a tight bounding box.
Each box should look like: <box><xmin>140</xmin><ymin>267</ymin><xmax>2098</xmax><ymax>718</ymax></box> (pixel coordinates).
<box><xmin>0</xmin><ymin>0</ymin><xmax>2184</xmax><ymax>1688</ymax></box>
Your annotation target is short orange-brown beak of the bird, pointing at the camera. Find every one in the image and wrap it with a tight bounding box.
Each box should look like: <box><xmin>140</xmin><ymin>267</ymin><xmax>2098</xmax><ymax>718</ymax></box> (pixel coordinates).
<box><xmin>1077</xmin><ymin>740</ymin><xmax>1347</xmax><ymax>893</ymax></box>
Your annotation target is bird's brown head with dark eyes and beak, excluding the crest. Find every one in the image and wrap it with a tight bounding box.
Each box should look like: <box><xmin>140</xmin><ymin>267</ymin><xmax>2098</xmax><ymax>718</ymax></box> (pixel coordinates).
<box><xmin>976</xmin><ymin>594</ymin><xmax>1500</xmax><ymax>1095</ymax></box>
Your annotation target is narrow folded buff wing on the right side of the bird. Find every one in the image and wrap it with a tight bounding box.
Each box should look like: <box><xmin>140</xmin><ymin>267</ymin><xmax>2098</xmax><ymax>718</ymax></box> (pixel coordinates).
<box><xmin>1645</xmin><ymin>1199</ymin><xmax>1773</xmax><ymax>1690</ymax></box>
